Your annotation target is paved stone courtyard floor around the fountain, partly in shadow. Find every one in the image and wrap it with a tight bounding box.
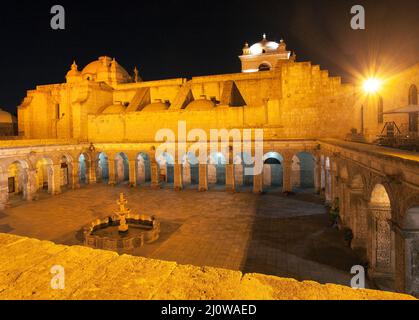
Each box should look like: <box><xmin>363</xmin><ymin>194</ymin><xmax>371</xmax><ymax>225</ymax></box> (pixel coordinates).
<box><xmin>0</xmin><ymin>185</ymin><xmax>366</xmax><ymax>285</ymax></box>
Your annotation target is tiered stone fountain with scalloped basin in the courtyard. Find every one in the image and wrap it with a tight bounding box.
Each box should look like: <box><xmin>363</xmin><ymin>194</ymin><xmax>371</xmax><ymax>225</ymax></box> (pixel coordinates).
<box><xmin>83</xmin><ymin>193</ymin><xmax>160</xmax><ymax>253</ymax></box>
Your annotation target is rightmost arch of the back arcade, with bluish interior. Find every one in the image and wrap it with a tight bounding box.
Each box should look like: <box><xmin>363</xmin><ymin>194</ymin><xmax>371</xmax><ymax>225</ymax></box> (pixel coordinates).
<box><xmin>291</xmin><ymin>152</ymin><xmax>315</xmax><ymax>193</ymax></box>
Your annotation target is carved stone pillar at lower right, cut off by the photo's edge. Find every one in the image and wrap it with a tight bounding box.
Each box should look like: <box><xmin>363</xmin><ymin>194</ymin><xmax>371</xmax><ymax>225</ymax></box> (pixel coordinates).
<box><xmin>393</xmin><ymin>225</ymin><xmax>419</xmax><ymax>296</ymax></box>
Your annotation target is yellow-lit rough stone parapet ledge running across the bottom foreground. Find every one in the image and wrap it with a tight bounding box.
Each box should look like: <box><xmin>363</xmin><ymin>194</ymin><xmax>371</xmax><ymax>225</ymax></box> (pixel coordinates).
<box><xmin>0</xmin><ymin>234</ymin><xmax>414</xmax><ymax>300</ymax></box>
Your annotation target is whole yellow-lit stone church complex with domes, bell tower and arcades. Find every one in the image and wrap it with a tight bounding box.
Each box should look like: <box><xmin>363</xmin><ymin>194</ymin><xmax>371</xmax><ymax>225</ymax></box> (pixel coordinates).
<box><xmin>0</xmin><ymin>35</ymin><xmax>419</xmax><ymax>295</ymax></box>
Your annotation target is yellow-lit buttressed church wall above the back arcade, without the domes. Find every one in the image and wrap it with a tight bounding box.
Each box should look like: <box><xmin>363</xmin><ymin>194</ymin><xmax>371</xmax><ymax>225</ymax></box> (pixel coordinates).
<box><xmin>19</xmin><ymin>62</ymin><xmax>356</xmax><ymax>141</ymax></box>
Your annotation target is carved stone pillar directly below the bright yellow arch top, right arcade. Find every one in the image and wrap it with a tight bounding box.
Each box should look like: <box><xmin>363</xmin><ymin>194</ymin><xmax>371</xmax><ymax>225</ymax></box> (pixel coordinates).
<box><xmin>367</xmin><ymin>206</ymin><xmax>395</xmax><ymax>277</ymax></box>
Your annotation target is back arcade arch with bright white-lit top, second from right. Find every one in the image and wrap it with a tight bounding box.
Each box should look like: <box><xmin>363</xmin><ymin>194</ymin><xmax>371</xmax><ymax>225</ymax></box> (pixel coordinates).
<box><xmin>263</xmin><ymin>152</ymin><xmax>284</xmax><ymax>189</ymax></box>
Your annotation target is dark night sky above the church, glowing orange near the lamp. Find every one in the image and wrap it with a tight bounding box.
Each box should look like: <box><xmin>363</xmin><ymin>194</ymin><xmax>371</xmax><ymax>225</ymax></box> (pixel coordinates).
<box><xmin>0</xmin><ymin>0</ymin><xmax>419</xmax><ymax>112</ymax></box>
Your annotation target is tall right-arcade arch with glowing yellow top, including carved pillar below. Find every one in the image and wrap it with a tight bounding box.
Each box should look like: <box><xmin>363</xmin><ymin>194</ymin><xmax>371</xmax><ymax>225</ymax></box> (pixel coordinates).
<box><xmin>368</xmin><ymin>184</ymin><xmax>395</xmax><ymax>284</ymax></box>
